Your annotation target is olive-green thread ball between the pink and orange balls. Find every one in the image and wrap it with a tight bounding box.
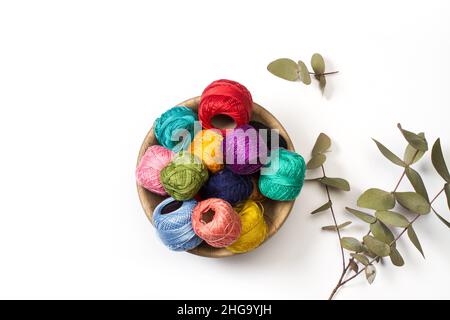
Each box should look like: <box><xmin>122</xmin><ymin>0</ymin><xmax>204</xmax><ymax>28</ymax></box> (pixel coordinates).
<box><xmin>161</xmin><ymin>151</ymin><xmax>208</xmax><ymax>200</ymax></box>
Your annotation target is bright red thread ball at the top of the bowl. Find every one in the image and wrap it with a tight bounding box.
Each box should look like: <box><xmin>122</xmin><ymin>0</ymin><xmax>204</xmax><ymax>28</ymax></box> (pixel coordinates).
<box><xmin>198</xmin><ymin>80</ymin><xmax>253</xmax><ymax>129</ymax></box>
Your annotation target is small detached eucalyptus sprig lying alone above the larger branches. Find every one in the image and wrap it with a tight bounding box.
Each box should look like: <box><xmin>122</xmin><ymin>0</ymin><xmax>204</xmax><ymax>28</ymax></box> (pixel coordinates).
<box><xmin>267</xmin><ymin>53</ymin><xmax>339</xmax><ymax>94</ymax></box>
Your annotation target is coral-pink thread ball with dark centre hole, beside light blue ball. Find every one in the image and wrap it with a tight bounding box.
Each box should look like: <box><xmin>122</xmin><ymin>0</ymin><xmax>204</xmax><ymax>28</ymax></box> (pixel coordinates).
<box><xmin>192</xmin><ymin>198</ymin><xmax>241</xmax><ymax>248</ymax></box>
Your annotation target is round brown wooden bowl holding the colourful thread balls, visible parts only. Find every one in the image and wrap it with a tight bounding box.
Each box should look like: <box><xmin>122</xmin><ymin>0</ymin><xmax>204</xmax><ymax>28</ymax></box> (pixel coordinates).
<box><xmin>137</xmin><ymin>97</ymin><xmax>294</xmax><ymax>258</ymax></box>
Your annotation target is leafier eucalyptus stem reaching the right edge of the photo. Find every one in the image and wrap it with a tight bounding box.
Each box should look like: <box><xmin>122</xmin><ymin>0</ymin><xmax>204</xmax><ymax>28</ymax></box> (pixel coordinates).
<box><xmin>310</xmin><ymin>124</ymin><xmax>450</xmax><ymax>299</ymax></box>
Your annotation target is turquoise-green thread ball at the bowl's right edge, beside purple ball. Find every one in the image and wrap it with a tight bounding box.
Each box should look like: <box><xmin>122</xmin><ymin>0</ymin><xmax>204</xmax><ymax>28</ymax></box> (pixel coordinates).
<box><xmin>259</xmin><ymin>148</ymin><xmax>306</xmax><ymax>201</ymax></box>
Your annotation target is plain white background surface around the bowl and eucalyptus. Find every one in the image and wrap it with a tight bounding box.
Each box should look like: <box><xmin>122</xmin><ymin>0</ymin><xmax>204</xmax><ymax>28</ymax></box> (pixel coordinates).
<box><xmin>0</xmin><ymin>0</ymin><xmax>450</xmax><ymax>299</ymax></box>
